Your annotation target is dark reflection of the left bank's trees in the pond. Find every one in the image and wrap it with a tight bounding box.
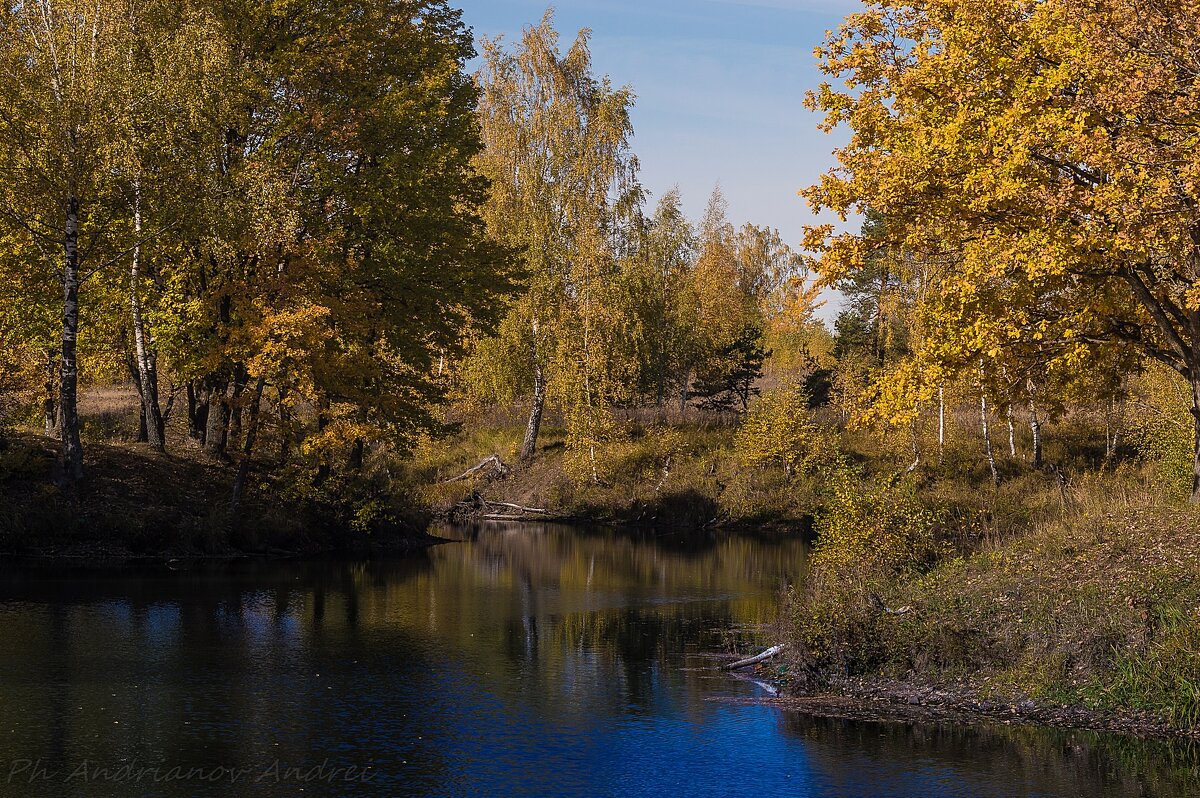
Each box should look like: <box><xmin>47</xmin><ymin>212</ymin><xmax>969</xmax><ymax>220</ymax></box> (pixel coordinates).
<box><xmin>0</xmin><ymin>560</ymin><xmax>451</xmax><ymax>796</ymax></box>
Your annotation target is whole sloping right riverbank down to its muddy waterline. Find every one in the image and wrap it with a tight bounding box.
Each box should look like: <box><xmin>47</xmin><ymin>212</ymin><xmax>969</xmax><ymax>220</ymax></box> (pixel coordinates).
<box><xmin>780</xmin><ymin>474</ymin><xmax>1200</xmax><ymax>737</ymax></box>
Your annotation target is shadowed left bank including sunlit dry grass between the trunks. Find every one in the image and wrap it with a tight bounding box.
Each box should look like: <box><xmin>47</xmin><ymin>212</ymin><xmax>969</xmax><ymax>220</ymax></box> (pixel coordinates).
<box><xmin>0</xmin><ymin>388</ymin><xmax>430</xmax><ymax>558</ymax></box>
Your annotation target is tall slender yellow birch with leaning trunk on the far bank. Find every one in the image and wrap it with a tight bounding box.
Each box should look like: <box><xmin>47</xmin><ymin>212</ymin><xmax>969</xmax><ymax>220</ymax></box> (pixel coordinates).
<box><xmin>478</xmin><ymin>12</ymin><xmax>640</xmax><ymax>461</ymax></box>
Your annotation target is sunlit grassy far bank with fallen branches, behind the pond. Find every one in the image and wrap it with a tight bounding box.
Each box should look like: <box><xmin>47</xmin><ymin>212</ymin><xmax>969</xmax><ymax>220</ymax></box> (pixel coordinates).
<box><xmin>403</xmin><ymin>412</ymin><xmax>817</xmax><ymax>530</ymax></box>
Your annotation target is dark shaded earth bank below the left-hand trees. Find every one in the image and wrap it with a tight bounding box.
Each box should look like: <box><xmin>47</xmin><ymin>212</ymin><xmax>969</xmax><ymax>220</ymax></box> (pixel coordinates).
<box><xmin>0</xmin><ymin>433</ymin><xmax>437</xmax><ymax>564</ymax></box>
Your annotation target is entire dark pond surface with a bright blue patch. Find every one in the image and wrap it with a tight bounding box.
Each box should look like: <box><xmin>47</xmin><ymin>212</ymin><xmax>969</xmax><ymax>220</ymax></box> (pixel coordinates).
<box><xmin>0</xmin><ymin>526</ymin><xmax>1200</xmax><ymax>798</ymax></box>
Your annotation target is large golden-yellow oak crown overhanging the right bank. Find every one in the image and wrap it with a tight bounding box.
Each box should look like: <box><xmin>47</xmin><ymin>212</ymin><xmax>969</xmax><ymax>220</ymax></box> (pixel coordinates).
<box><xmin>806</xmin><ymin>0</ymin><xmax>1200</xmax><ymax>502</ymax></box>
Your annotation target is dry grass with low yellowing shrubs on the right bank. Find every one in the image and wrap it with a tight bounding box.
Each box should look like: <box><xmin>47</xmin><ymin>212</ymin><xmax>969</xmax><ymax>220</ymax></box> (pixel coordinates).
<box><xmin>791</xmin><ymin>420</ymin><xmax>1200</xmax><ymax>727</ymax></box>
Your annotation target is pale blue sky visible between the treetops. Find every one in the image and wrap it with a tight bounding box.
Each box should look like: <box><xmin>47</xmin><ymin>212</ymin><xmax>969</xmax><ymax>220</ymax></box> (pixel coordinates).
<box><xmin>451</xmin><ymin>0</ymin><xmax>860</xmax><ymax>318</ymax></box>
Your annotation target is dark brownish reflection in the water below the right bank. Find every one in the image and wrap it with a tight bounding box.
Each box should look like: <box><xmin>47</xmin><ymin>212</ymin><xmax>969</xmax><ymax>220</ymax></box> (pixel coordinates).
<box><xmin>780</xmin><ymin>712</ymin><xmax>1200</xmax><ymax>798</ymax></box>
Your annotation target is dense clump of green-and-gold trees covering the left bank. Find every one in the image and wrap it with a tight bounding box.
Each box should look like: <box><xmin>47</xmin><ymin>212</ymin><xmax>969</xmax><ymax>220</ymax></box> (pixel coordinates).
<box><xmin>0</xmin><ymin>0</ymin><xmax>514</xmax><ymax>501</ymax></box>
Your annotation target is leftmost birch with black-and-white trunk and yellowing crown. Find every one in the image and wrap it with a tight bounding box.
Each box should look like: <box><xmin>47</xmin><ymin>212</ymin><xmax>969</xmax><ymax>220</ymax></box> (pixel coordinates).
<box><xmin>0</xmin><ymin>0</ymin><xmax>138</xmax><ymax>481</ymax></box>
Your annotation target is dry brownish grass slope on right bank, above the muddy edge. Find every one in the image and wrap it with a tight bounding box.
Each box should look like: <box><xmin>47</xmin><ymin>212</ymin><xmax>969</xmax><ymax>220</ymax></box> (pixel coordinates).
<box><xmin>884</xmin><ymin>478</ymin><xmax>1200</xmax><ymax>725</ymax></box>
